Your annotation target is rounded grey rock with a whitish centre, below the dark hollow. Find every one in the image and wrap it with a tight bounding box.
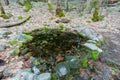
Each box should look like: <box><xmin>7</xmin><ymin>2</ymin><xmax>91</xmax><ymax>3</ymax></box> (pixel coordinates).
<box><xmin>56</xmin><ymin>62</ymin><xmax>70</xmax><ymax>77</ymax></box>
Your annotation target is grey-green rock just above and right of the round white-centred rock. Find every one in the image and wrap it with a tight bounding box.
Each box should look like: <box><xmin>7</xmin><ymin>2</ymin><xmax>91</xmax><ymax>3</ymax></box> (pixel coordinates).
<box><xmin>65</xmin><ymin>56</ymin><xmax>80</xmax><ymax>68</ymax></box>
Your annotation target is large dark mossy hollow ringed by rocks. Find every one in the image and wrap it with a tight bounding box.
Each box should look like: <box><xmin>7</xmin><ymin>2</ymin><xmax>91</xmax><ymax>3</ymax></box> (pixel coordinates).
<box><xmin>20</xmin><ymin>27</ymin><xmax>88</xmax><ymax>57</ymax></box>
